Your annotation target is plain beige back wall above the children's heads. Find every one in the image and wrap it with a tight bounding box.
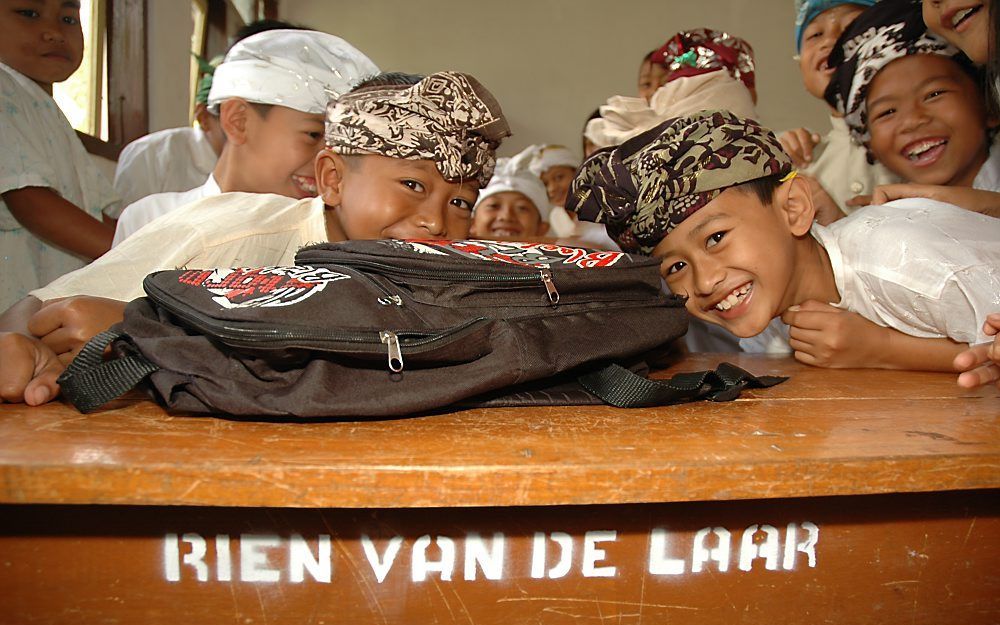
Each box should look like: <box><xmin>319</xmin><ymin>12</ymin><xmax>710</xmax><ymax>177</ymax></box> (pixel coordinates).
<box><xmin>276</xmin><ymin>0</ymin><xmax>829</xmax><ymax>154</ymax></box>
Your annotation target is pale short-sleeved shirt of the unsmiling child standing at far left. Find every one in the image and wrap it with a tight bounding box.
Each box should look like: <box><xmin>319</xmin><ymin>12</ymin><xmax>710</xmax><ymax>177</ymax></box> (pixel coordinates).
<box><xmin>0</xmin><ymin>63</ymin><xmax>121</xmax><ymax>311</ymax></box>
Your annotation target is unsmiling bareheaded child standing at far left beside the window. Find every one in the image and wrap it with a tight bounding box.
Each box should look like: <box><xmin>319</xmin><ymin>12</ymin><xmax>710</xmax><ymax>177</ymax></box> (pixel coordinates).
<box><xmin>0</xmin><ymin>0</ymin><xmax>121</xmax><ymax>309</ymax></box>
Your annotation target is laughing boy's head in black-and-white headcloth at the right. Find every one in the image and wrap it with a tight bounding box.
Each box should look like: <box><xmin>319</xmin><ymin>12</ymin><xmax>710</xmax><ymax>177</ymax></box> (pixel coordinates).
<box><xmin>826</xmin><ymin>0</ymin><xmax>1000</xmax><ymax>215</ymax></box>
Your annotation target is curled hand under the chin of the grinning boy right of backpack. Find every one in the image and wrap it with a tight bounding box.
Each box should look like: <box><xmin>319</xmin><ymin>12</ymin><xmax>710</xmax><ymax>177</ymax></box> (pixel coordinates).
<box><xmin>781</xmin><ymin>300</ymin><xmax>891</xmax><ymax>369</ymax></box>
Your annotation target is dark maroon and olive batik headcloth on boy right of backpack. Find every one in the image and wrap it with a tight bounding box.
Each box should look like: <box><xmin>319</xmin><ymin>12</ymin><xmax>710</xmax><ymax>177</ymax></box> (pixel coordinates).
<box><xmin>566</xmin><ymin>111</ymin><xmax>792</xmax><ymax>255</ymax></box>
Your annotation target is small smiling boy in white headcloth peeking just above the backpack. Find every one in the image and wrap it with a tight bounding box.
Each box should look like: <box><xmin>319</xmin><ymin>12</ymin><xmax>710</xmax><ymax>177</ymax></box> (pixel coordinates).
<box><xmin>469</xmin><ymin>151</ymin><xmax>552</xmax><ymax>241</ymax></box>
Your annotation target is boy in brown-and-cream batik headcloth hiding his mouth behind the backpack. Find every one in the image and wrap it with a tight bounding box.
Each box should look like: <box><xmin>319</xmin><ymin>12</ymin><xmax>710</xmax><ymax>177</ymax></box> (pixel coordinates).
<box><xmin>0</xmin><ymin>72</ymin><xmax>510</xmax><ymax>405</ymax></box>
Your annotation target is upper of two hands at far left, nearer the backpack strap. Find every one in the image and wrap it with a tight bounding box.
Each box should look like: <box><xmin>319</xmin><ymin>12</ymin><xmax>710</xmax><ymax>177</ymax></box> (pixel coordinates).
<box><xmin>28</xmin><ymin>295</ymin><xmax>125</xmax><ymax>365</ymax></box>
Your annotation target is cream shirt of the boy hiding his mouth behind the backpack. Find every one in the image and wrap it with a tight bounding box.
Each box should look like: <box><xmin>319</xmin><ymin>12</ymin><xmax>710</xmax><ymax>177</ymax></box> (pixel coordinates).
<box><xmin>31</xmin><ymin>193</ymin><xmax>327</xmax><ymax>301</ymax></box>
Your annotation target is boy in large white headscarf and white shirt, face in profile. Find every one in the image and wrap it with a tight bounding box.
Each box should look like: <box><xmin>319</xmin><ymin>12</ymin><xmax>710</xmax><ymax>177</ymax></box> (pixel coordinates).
<box><xmin>114</xmin><ymin>29</ymin><xmax>378</xmax><ymax>245</ymax></box>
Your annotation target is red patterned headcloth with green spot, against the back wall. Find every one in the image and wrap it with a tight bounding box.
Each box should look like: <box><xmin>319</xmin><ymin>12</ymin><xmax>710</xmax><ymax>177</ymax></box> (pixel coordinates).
<box><xmin>649</xmin><ymin>28</ymin><xmax>756</xmax><ymax>89</ymax></box>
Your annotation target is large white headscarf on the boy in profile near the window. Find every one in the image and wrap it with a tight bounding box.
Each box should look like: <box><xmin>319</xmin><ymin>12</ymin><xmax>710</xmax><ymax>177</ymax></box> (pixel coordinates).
<box><xmin>208</xmin><ymin>30</ymin><xmax>379</xmax><ymax>114</ymax></box>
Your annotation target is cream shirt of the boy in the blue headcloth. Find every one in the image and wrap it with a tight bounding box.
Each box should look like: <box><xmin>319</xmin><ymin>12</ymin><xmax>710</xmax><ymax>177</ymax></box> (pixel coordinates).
<box><xmin>802</xmin><ymin>115</ymin><xmax>902</xmax><ymax>215</ymax></box>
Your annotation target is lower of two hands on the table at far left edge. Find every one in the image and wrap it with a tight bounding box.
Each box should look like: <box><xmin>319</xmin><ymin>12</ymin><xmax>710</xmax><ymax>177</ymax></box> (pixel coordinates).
<box><xmin>0</xmin><ymin>332</ymin><xmax>65</xmax><ymax>406</ymax></box>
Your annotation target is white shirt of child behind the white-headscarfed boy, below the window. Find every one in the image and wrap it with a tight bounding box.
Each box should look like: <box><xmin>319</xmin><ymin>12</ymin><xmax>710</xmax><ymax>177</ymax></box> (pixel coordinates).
<box><xmin>115</xmin><ymin>127</ymin><xmax>219</xmax><ymax>206</ymax></box>
